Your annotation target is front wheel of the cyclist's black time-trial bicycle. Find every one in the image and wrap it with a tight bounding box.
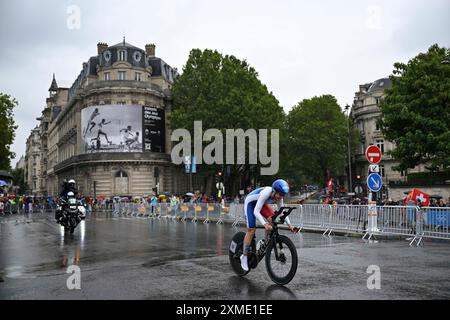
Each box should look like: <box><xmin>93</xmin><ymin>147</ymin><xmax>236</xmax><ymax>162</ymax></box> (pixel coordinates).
<box><xmin>266</xmin><ymin>235</ymin><xmax>298</xmax><ymax>285</ymax></box>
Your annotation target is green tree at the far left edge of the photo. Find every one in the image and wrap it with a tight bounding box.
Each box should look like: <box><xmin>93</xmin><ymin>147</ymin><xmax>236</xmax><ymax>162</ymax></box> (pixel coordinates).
<box><xmin>0</xmin><ymin>93</ymin><xmax>17</xmax><ymax>170</ymax></box>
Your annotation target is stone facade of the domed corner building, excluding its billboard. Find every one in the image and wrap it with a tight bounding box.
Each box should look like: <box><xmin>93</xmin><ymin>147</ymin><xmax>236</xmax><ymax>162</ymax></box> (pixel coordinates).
<box><xmin>26</xmin><ymin>39</ymin><xmax>187</xmax><ymax>197</ymax></box>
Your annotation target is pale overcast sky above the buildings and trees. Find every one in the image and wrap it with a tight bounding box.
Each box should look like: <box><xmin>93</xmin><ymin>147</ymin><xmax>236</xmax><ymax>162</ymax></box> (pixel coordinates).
<box><xmin>0</xmin><ymin>0</ymin><xmax>450</xmax><ymax>165</ymax></box>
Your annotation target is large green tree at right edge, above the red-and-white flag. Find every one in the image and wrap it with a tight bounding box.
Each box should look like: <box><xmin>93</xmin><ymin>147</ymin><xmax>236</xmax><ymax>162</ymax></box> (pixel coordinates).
<box><xmin>379</xmin><ymin>44</ymin><xmax>450</xmax><ymax>171</ymax></box>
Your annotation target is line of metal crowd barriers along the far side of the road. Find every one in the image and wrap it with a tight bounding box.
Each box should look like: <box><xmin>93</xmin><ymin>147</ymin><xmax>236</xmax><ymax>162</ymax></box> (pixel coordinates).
<box><xmin>0</xmin><ymin>202</ymin><xmax>450</xmax><ymax>245</ymax></box>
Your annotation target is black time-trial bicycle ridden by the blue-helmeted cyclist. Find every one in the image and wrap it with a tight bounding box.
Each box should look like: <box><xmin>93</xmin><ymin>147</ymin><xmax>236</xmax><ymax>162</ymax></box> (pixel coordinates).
<box><xmin>229</xmin><ymin>207</ymin><xmax>298</xmax><ymax>285</ymax></box>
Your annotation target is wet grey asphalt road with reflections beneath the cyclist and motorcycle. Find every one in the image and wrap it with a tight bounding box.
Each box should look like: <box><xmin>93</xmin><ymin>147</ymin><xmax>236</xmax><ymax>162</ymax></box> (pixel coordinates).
<box><xmin>0</xmin><ymin>213</ymin><xmax>450</xmax><ymax>300</ymax></box>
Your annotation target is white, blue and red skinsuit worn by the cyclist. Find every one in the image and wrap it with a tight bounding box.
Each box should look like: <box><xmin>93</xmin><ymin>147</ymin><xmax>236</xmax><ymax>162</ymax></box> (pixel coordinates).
<box><xmin>244</xmin><ymin>187</ymin><xmax>290</xmax><ymax>228</ymax></box>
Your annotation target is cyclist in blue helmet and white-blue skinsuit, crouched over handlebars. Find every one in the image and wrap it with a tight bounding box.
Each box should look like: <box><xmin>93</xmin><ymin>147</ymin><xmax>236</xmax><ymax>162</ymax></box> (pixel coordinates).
<box><xmin>241</xmin><ymin>179</ymin><xmax>298</xmax><ymax>271</ymax></box>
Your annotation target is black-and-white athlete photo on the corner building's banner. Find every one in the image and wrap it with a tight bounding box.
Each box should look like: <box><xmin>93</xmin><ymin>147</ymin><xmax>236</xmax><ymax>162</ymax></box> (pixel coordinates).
<box><xmin>81</xmin><ymin>105</ymin><xmax>142</xmax><ymax>153</ymax></box>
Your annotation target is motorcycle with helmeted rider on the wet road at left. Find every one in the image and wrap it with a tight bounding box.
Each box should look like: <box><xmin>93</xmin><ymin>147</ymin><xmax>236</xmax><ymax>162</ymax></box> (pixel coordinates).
<box><xmin>57</xmin><ymin>192</ymin><xmax>85</xmax><ymax>234</ymax></box>
